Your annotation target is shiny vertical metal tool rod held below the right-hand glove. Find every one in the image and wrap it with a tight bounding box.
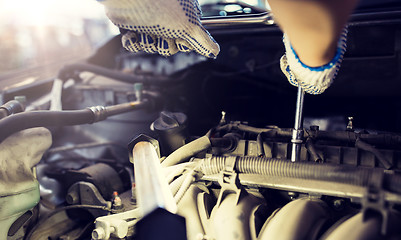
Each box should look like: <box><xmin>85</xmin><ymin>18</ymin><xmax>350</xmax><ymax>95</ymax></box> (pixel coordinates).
<box><xmin>291</xmin><ymin>86</ymin><xmax>305</xmax><ymax>162</ymax></box>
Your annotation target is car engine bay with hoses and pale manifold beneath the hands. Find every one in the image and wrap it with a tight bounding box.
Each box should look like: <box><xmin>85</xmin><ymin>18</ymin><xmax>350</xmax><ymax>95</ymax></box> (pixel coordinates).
<box><xmin>0</xmin><ymin>4</ymin><xmax>401</xmax><ymax>240</ymax></box>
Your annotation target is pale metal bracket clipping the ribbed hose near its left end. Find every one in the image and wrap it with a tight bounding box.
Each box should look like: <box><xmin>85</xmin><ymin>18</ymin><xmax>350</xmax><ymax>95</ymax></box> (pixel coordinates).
<box><xmin>216</xmin><ymin>156</ymin><xmax>244</xmax><ymax>206</ymax></box>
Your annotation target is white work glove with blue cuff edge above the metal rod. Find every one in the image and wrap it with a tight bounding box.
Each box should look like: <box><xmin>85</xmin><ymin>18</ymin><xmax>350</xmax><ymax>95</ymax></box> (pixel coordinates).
<box><xmin>280</xmin><ymin>28</ymin><xmax>348</xmax><ymax>94</ymax></box>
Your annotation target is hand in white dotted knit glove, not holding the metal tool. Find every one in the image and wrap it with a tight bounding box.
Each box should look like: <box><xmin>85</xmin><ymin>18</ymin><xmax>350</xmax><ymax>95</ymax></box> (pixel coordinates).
<box><xmin>98</xmin><ymin>0</ymin><xmax>220</xmax><ymax>58</ymax></box>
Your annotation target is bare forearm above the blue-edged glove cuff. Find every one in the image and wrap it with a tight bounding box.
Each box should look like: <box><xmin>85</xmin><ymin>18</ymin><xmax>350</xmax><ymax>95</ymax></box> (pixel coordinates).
<box><xmin>269</xmin><ymin>0</ymin><xmax>358</xmax><ymax>67</ymax></box>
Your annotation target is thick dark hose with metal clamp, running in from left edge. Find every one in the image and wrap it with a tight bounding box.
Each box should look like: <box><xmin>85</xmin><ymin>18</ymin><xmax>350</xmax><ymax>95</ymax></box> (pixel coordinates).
<box><xmin>0</xmin><ymin>101</ymin><xmax>148</xmax><ymax>142</ymax></box>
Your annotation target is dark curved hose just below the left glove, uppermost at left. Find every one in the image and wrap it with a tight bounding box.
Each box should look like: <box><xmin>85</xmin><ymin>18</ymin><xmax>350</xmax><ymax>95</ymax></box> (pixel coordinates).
<box><xmin>58</xmin><ymin>63</ymin><xmax>168</xmax><ymax>84</ymax></box>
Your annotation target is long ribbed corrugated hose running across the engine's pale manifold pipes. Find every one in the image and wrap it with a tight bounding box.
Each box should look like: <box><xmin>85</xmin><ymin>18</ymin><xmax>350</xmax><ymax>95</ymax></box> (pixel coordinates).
<box><xmin>201</xmin><ymin>157</ymin><xmax>401</xmax><ymax>193</ymax></box>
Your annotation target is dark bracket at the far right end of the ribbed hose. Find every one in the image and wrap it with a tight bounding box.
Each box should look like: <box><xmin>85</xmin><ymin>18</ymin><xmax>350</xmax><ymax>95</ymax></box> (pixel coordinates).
<box><xmin>361</xmin><ymin>170</ymin><xmax>389</xmax><ymax>235</ymax></box>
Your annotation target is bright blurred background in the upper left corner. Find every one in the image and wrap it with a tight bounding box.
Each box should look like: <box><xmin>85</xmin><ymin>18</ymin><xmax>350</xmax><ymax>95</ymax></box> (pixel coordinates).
<box><xmin>0</xmin><ymin>0</ymin><xmax>118</xmax><ymax>81</ymax></box>
